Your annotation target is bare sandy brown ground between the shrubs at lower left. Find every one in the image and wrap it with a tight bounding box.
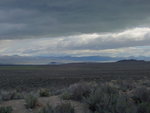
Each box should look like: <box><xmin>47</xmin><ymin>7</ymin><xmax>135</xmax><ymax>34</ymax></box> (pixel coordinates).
<box><xmin>0</xmin><ymin>96</ymin><xmax>89</xmax><ymax>113</ymax></box>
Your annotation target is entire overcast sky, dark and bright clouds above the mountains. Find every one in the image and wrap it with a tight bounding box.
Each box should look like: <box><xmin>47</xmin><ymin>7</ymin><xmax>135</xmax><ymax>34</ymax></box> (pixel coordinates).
<box><xmin>0</xmin><ymin>0</ymin><xmax>150</xmax><ymax>57</ymax></box>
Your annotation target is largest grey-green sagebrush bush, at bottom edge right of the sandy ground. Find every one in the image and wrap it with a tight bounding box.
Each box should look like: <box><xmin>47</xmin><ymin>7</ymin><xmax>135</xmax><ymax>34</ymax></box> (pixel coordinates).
<box><xmin>84</xmin><ymin>85</ymin><xmax>137</xmax><ymax>113</ymax></box>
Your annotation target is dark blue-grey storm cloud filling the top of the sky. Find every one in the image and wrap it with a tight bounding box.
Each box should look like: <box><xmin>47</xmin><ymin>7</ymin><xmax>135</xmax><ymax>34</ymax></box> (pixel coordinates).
<box><xmin>0</xmin><ymin>0</ymin><xmax>150</xmax><ymax>39</ymax></box>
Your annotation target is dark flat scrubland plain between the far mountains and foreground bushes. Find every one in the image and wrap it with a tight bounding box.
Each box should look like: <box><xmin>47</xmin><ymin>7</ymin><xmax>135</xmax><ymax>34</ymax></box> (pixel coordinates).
<box><xmin>0</xmin><ymin>62</ymin><xmax>150</xmax><ymax>89</ymax></box>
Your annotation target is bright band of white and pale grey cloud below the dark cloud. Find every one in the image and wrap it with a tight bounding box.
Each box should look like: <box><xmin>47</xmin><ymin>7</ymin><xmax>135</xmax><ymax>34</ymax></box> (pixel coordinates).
<box><xmin>0</xmin><ymin>27</ymin><xmax>150</xmax><ymax>56</ymax></box>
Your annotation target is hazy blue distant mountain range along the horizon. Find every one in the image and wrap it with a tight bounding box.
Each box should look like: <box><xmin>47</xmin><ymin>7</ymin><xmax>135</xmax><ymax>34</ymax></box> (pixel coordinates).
<box><xmin>0</xmin><ymin>55</ymin><xmax>150</xmax><ymax>65</ymax></box>
